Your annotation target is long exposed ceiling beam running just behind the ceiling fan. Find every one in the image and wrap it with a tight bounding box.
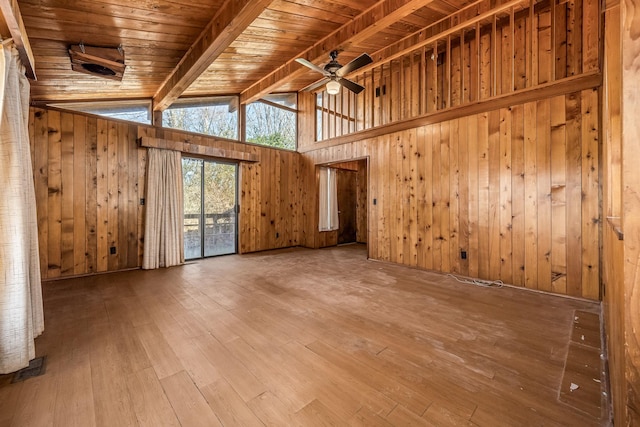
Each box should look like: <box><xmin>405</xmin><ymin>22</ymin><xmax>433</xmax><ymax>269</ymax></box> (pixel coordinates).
<box><xmin>240</xmin><ymin>0</ymin><xmax>434</xmax><ymax>104</ymax></box>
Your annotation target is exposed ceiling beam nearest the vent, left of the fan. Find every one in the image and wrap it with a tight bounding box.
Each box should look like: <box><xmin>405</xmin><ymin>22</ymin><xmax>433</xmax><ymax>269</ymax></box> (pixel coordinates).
<box><xmin>153</xmin><ymin>0</ymin><xmax>272</xmax><ymax>111</ymax></box>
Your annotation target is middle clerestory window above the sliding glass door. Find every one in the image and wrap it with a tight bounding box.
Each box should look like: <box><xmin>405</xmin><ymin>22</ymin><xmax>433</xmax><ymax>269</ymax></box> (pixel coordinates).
<box><xmin>162</xmin><ymin>96</ymin><xmax>238</xmax><ymax>139</ymax></box>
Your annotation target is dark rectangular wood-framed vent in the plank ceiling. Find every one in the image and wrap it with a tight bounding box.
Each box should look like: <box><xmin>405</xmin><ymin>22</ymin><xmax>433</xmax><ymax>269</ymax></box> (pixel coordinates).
<box><xmin>69</xmin><ymin>43</ymin><xmax>125</xmax><ymax>81</ymax></box>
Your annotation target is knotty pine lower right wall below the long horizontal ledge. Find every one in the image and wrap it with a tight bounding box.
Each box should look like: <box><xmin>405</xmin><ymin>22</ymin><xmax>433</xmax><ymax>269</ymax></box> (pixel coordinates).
<box><xmin>302</xmin><ymin>89</ymin><xmax>601</xmax><ymax>299</ymax></box>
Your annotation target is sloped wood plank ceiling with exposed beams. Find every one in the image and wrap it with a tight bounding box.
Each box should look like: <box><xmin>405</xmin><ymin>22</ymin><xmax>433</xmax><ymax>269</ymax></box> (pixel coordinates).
<box><xmin>13</xmin><ymin>0</ymin><xmax>471</xmax><ymax>109</ymax></box>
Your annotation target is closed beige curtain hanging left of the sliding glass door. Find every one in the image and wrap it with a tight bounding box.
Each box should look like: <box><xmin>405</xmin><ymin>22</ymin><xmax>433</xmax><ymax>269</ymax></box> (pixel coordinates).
<box><xmin>142</xmin><ymin>148</ymin><xmax>184</xmax><ymax>269</ymax></box>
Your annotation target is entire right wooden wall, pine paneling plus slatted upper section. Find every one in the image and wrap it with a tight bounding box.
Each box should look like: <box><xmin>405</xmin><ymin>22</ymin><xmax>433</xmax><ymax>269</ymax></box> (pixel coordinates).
<box><xmin>299</xmin><ymin>0</ymin><xmax>602</xmax><ymax>299</ymax></box>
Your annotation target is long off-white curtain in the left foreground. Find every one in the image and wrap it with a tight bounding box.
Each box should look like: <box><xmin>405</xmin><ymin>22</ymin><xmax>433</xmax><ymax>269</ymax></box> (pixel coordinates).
<box><xmin>0</xmin><ymin>43</ymin><xmax>44</xmax><ymax>374</ymax></box>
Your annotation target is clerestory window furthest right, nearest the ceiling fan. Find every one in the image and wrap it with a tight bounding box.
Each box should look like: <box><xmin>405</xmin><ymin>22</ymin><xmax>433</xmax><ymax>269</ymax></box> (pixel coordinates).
<box><xmin>245</xmin><ymin>93</ymin><xmax>297</xmax><ymax>150</ymax></box>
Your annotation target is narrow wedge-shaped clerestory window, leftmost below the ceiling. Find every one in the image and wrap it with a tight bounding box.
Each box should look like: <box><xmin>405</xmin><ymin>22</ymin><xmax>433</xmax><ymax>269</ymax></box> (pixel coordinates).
<box><xmin>49</xmin><ymin>101</ymin><xmax>151</xmax><ymax>124</ymax></box>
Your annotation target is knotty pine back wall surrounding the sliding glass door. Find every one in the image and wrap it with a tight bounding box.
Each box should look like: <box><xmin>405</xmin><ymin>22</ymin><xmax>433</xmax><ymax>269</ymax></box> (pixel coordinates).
<box><xmin>30</xmin><ymin>108</ymin><xmax>300</xmax><ymax>279</ymax></box>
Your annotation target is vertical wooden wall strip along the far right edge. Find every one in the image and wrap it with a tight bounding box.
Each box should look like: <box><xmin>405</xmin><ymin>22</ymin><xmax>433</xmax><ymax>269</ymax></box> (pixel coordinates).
<box><xmin>602</xmin><ymin>0</ymin><xmax>640</xmax><ymax>426</ymax></box>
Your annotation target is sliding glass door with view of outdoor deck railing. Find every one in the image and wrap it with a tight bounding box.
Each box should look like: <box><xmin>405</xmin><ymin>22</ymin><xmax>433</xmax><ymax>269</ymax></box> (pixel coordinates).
<box><xmin>182</xmin><ymin>158</ymin><xmax>238</xmax><ymax>259</ymax></box>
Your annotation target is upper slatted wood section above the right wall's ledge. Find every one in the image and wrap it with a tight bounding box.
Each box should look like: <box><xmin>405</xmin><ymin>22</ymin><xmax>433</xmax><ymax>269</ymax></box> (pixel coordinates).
<box><xmin>315</xmin><ymin>0</ymin><xmax>600</xmax><ymax>140</ymax></box>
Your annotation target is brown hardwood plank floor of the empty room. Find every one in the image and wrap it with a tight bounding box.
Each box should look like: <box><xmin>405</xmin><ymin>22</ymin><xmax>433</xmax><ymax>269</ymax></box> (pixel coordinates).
<box><xmin>0</xmin><ymin>245</ymin><xmax>608</xmax><ymax>427</ymax></box>
